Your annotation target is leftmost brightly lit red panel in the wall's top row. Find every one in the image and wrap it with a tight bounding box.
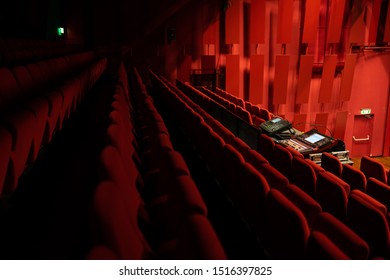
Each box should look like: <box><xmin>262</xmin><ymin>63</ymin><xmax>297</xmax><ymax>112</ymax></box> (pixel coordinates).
<box><xmin>225</xmin><ymin>0</ymin><xmax>242</xmax><ymax>44</ymax></box>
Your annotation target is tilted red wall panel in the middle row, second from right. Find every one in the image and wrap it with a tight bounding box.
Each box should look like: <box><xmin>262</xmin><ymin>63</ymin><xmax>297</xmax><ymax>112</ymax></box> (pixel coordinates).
<box><xmin>318</xmin><ymin>55</ymin><xmax>337</xmax><ymax>103</ymax></box>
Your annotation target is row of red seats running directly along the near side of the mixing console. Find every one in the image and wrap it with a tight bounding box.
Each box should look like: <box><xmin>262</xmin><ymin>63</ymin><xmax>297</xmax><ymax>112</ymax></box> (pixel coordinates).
<box><xmin>253</xmin><ymin>134</ymin><xmax>390</xmax><ymax>258</ymax></box>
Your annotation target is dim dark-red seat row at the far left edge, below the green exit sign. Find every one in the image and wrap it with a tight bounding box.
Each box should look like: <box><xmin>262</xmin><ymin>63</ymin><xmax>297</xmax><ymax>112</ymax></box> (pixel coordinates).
<box><xmin>0</xmin><ymin>55</ymin><xmax>107</xmax><ymax>194</ymax></box>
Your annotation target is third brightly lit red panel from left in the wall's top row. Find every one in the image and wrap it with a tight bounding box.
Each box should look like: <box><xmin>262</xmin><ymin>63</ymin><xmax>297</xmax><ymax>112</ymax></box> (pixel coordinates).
<box><xmin>276</xmin><ymin>0</ymin><xmax>294</xmax><ymax>44</ymax></box>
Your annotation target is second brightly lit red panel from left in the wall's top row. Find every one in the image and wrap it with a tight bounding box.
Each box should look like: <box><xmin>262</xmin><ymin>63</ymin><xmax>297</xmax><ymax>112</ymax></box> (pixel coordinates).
<box><xmin>250</xmin><ymin>0</ymin><xmax>265</xmax><ymax>44</ymax></box>
